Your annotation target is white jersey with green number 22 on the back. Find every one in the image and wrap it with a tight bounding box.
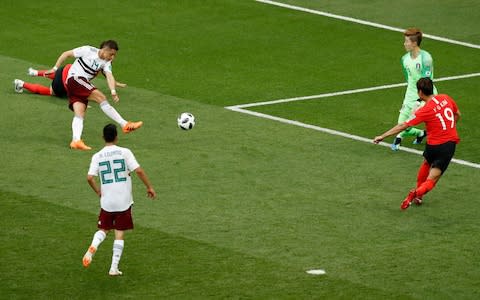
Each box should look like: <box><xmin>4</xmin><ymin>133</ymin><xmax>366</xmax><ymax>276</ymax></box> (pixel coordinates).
<box><xmin>88</xmin><ymin>145</ymin><xmax>140</xmax><ymax>212</ymax></box>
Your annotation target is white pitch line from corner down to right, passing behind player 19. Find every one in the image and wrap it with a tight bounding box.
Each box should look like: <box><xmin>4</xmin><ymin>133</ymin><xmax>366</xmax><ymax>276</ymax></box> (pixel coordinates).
<box><xmin>225</xmin><ymin>106</ymin><xmax>480</xmax><ymax>169</ymax></box>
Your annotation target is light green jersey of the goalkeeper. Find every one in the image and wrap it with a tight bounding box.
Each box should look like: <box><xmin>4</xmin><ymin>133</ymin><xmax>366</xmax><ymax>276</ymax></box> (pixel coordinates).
<box><xmin>401</xmin><ymin>50</ymin><xmax>437</xmax><ymax>109</ymax></box>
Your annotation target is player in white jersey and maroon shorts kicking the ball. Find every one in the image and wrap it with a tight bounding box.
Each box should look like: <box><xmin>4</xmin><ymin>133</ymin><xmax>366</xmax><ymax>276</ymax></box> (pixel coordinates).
<box><xmin>45</xmin><ymin>40</ymin><xmax>143</xmax><ymax>150</ymax></box>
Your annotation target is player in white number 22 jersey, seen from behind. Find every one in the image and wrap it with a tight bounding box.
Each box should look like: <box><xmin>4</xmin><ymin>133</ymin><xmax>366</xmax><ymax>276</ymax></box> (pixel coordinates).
<box><xmin>82</xmin><ymin>124</ymin><xmax>156</xmax><ymax>276</ymax></box>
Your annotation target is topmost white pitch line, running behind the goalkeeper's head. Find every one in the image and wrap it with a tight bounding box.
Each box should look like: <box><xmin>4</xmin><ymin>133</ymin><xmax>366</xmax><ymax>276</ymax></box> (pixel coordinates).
<box><xmin>255</xmin><ymin>0</ymin><xmax>480</xmax><ymax>49</ymax></box>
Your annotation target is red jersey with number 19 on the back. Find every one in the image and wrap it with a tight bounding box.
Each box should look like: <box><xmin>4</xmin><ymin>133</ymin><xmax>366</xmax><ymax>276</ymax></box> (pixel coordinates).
<box><xmin>405</xmin><ymin>94</ymin><xmax>460</xmax><ymax>145</ymax></box>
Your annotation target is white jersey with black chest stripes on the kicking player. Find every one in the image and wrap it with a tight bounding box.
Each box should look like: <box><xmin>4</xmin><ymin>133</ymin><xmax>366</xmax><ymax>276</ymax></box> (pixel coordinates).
<box><xmin>67</xmin><ymin>46</ymin><xmax>112</xmax><ymax>81</ymax></box>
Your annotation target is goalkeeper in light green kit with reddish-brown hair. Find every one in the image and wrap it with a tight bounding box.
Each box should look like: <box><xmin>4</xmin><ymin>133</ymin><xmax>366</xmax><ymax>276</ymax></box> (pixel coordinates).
<box><xmin>391</xmin><ymin>28</ymin><xmax>437</xmax><ymax>151</ymax></box>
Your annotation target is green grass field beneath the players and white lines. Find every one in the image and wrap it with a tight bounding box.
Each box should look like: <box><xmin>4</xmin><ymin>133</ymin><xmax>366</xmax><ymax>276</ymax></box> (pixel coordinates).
<box><xmin>0</xmin><ymin>0</ymin><xmax>480</xmax><ymax>299</ymax></box>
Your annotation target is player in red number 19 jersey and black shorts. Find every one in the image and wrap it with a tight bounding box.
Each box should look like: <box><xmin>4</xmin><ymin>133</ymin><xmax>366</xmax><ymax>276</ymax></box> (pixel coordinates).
<box><xmin>373</xmin><ymin>78</ymin><xmax>460</xmax><ymax>209</ymax></box>
